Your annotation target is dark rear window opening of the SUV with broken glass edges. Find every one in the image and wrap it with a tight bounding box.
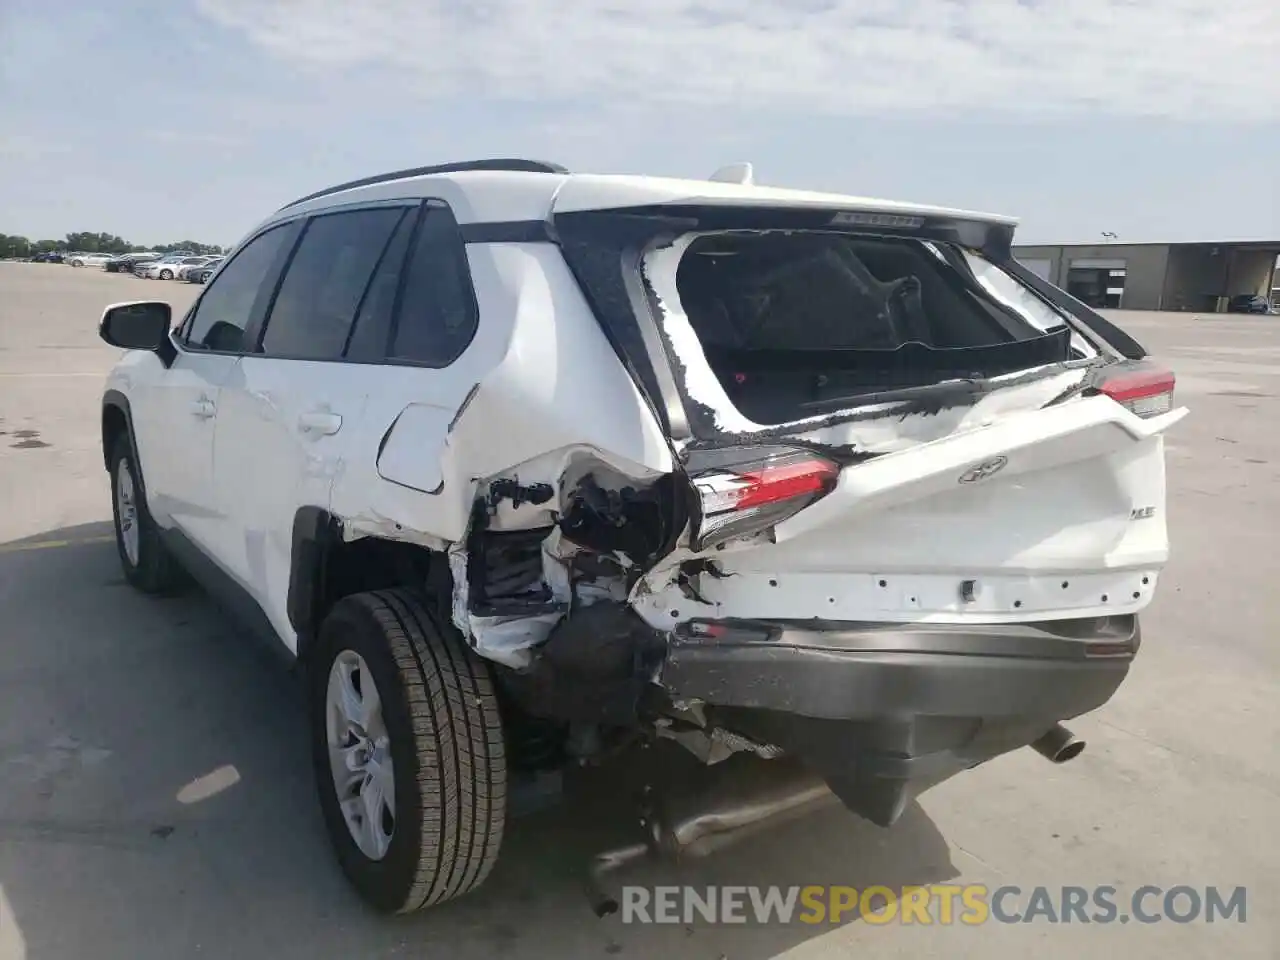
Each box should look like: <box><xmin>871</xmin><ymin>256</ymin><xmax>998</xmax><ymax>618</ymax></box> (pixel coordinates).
<box><xmin>650</xmin><ymin>230</ymin><xmax>1070</xmax><ymax>424</ymax></box>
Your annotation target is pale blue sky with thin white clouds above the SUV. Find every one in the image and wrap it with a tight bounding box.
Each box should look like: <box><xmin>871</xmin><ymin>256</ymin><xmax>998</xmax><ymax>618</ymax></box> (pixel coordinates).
<box><xmin>0</xmin><ymin>0</ymin><xmax>1280</xmax><ymax>244</ymax></box>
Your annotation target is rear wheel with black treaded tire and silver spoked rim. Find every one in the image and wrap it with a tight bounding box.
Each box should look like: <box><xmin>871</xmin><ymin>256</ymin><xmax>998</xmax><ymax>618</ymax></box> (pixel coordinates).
<box><xmin>308</xmin><ymin>589</ymin><xmax>507</xmax><ymax>913</ymax></box>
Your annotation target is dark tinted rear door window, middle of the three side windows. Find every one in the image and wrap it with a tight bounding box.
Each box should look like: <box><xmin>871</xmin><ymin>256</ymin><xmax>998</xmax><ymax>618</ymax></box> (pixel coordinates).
<box><xmin>262</xmin><ymin>207</ymin><xmax>404</xmax><ymax>360</ymax></box>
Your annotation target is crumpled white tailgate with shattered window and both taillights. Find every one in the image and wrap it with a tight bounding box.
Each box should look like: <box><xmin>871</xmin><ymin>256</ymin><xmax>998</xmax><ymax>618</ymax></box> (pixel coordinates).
<box><xmin>599</xmin><ymin>227</ymin><xmax>1184</xmax><ymax>630</ymax></box>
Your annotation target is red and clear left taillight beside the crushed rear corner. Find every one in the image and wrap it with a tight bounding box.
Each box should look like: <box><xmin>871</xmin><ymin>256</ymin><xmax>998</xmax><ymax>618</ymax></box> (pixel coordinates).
<box><xmin>689</xmin><ymin>447</ymin><xmax>840</xmax><ymax>550</ymax></box>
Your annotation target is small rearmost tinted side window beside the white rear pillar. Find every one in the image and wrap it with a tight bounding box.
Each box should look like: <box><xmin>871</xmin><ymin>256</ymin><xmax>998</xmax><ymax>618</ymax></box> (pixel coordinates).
<box><xmin>387</xmin><ymin>206</ymin><xmax>477</xmax><ymax>367</ymax></box>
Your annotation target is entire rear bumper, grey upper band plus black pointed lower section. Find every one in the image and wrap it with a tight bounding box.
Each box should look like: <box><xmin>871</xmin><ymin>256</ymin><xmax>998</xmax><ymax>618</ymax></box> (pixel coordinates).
<box><xmin>662</xmin><ymin>616</ymin><xmax>1140</xmax><ymax>826</ymax></box>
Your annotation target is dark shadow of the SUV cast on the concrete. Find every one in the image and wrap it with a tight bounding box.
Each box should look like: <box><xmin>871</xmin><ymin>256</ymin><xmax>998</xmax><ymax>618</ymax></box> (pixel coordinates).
<box><xmin>0</xmin><ymin>524</ymin><xmax>957</xmax><ymax>960</ymax></box>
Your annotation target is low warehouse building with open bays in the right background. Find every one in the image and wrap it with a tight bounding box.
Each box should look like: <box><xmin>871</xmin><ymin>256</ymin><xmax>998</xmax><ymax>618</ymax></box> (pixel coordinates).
<box><xmin>1014</xmin><ymin>241</ymin><xmax>1280</xmax><ymax>312</ymax></box>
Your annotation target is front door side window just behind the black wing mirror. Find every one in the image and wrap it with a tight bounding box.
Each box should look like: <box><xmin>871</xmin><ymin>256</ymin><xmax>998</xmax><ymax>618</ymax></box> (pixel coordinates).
<box><xmin>184</xmin><ymin>224</ymin><xmax>294</xmax><ymax>353</ymax></box>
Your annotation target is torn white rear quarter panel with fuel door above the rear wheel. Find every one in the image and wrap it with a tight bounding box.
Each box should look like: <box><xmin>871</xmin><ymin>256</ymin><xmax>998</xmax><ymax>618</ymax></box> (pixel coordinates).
<box><xmin>333</xmin><ymin>243</ymin><xmax>675</xmax><ymax>666</ymax></box>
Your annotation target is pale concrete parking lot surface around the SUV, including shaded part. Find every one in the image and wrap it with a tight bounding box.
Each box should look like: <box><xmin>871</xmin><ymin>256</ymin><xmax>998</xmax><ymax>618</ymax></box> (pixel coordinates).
<box><xmin>0</xmin><ymin>264</ymin><xmax>1280</xmax><ymax>960</ymax></box>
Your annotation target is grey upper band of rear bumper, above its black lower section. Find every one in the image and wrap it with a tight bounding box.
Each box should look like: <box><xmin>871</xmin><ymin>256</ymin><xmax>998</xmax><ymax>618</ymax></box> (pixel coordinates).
<box><xmin>662</xmin><ymin>616</ymin><xmax>1140</xmax><ymax>719</ymax></box>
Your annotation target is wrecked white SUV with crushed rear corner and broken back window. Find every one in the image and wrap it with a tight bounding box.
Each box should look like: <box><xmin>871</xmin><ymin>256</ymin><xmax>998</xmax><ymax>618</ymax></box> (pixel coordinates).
<box><xmin>101</xmin><ymin>160</ymin><xmax>1185</xmax><ymax>911</ymax></box>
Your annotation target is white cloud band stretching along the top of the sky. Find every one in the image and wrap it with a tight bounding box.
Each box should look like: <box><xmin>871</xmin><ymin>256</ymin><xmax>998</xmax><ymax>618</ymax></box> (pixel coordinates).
<box><xmin>198</xmin><ymin>0</ymin><xmax>1280</xmax><ymax>122</ymax></box>
